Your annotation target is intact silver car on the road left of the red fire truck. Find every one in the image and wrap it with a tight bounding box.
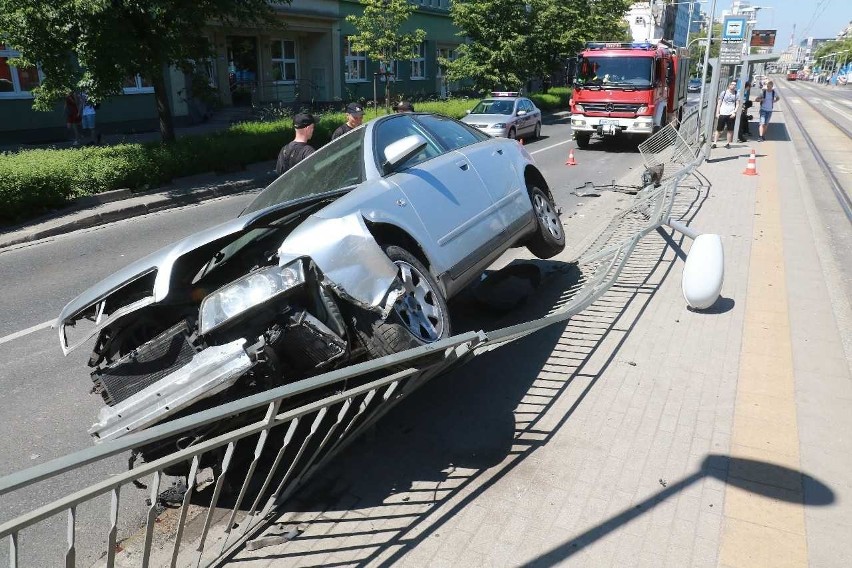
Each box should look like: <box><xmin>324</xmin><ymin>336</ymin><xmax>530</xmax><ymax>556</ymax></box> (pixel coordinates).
<box><xmin>462</xmin><ymin>93</ymin><xmax>541</xmax><ymax>138</ymax></box>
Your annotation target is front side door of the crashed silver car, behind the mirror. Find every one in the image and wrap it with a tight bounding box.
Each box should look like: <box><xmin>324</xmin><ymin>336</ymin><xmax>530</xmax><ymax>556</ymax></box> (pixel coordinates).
<box><xmin>374</xmin><ymin>115</ymin><xmax>504</xmax><ymax>276</ymax></box>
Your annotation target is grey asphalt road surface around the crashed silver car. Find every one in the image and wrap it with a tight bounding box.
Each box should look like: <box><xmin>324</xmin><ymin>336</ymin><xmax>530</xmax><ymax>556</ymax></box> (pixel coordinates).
<box><xmin>0</xmin><ymin>115</ymin><xmax>642</xmax><ymax>565</ymax></box>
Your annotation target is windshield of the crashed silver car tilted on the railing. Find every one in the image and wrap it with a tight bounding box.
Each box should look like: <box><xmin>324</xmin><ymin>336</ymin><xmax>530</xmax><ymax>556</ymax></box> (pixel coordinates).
<box><xmin>243</xmin><ymin>128</ymin><xmax>364</xmax><ymax>214</ymax></box>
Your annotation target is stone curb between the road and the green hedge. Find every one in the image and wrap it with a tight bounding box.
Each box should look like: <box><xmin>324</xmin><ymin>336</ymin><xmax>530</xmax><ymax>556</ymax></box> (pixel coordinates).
<box><xmin>0</xmin><ymin>174</ymin><xmax>277</xmax><ymax>250</ymax></box>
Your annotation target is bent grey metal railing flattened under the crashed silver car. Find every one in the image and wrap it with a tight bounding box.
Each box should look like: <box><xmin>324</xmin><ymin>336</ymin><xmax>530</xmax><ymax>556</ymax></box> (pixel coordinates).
<box><xmin>0</xmin><ymin>115</ymin><xmax>703</xmax><ymax>568</ymax></box>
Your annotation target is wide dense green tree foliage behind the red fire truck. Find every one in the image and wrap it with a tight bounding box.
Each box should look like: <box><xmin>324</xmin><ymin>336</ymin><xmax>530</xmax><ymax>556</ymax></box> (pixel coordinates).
<box><xmin>440</xmin><ymin>0</ymin><xmax>631</xmax><ymax>90</ymax></box>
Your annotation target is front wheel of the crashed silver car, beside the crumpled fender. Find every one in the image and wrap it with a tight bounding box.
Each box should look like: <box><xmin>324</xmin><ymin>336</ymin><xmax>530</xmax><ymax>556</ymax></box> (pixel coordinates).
<box><xmin>358</xmin><ymin>245</ymin><xmax>452</xmax><ymax>357</ymax></box>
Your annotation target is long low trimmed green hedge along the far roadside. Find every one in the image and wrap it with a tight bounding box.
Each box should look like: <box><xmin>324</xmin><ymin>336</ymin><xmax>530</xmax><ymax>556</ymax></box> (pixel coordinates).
<box><xmin>5</xmin><ymin>93</ymin><xmax>567</xmax><ymax>226</ymax></box>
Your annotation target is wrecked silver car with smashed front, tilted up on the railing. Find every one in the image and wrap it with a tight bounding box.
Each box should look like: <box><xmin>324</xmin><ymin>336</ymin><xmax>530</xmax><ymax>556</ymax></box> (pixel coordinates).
<box><xmin>57</xmin><ymin>113</ymin><xmax>565</xmax><ymax>466</ymax></box>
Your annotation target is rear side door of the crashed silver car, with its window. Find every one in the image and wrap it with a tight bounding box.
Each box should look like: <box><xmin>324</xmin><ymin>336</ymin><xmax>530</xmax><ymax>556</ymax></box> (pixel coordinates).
<box><xmin>421</xmin><ymin>116</ymin><xmax>531</xmax><ymax>236</ymax></box>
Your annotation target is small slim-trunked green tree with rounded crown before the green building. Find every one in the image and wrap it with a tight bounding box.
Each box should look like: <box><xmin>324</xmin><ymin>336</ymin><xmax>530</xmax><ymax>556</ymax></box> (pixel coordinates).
<box><xmin>346</xmin><ymin>0</ymin><xmax>426</xmax><ymax>112</ymax></box>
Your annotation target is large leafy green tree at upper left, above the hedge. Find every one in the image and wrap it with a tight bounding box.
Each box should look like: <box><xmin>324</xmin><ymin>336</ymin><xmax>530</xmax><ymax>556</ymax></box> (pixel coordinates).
<box><xmin>0</xmin><ymin>0</ymin><xmax>278</xmax><ymax>142</ymax></box>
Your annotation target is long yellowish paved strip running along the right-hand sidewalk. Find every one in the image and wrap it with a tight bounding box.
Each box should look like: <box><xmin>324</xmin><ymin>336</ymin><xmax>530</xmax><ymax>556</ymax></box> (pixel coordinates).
<box><xmin>719</xmin><ymin>142</ymin><xmax>808</xmax><ymax>568</ymax></box>
